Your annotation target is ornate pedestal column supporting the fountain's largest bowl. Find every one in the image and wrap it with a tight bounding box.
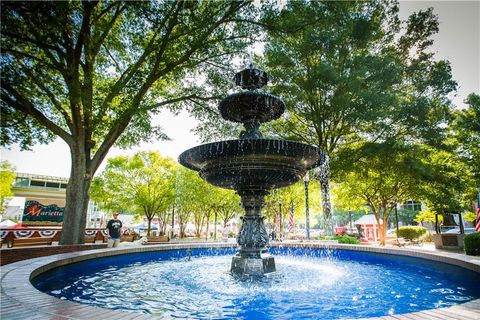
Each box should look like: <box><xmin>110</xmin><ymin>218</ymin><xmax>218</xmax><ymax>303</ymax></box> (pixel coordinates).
<box><xmin>231</xmin><ymin>191</ymin><xmax>275</xmax><ymax>276</ymax></box>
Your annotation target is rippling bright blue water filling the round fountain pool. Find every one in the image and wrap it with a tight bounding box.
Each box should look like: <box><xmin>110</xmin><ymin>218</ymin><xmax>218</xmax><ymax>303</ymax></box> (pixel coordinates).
<box><xmin>32</xmin><ymin>248</ymin><xmax>480</xmax><ymax>319</ymax></box>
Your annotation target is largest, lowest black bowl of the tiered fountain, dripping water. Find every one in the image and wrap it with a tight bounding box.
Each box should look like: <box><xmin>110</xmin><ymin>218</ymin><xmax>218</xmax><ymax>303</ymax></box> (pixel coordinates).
<box><xmin>179</xmin><ymin>139</ymin><xmax>324</xmax><ymax>191</ymax></box>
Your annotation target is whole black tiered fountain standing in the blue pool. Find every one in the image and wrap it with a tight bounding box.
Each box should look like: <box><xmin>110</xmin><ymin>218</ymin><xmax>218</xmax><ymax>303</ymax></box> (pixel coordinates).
<box><xmin>179</xmin><ymin>66</ymin><xmax>325</xmax><ymax>276</ymax></box>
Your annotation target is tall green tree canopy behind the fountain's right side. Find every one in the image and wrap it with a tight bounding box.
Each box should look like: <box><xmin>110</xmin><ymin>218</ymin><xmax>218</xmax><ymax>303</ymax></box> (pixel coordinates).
<box><xmin>264</xmin><ymin>1</ymin><xmax>456</xmax><ymax>178</ymax></box>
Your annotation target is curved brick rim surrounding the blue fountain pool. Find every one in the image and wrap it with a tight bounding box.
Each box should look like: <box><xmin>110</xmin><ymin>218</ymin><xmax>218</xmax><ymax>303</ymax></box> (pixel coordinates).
<box><xmin>1</xmin><ymin>242</ymin><xmax>480</xmax><ymax>320</ymax></box>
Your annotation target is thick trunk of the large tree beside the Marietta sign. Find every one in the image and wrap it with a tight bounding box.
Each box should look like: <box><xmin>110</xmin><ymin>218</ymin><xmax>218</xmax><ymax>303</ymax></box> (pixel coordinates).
<box><xmin>60</xmin><ymin>147</ymin><xmax>93</xmax><ymax>245</ymax></box>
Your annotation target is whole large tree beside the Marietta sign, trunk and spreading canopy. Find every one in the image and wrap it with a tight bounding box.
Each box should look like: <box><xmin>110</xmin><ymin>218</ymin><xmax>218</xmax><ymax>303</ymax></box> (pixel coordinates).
<box><xmin>0</xmin><ymin>1</ymin><xmax>252</xmax><ymax>244</ymax></box>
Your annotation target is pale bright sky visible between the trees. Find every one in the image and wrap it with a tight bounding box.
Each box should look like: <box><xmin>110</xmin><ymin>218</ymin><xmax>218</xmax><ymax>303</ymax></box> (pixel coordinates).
<box><xmin>0</xmin><ymin>1</ymin><xmax>480</xmax><ymax>177</ymax></box>
